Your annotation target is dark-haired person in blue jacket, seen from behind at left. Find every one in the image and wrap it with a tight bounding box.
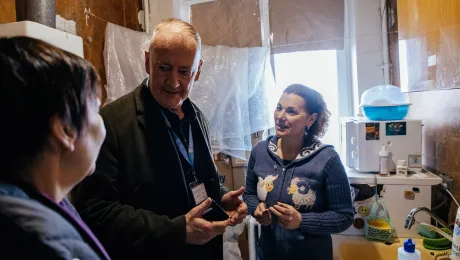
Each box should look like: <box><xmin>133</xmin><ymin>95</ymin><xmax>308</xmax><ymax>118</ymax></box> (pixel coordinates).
<box><xmin>0</xmin><ymin>37</ymin><xmax>109</xmax><ymax>259</ymax></box>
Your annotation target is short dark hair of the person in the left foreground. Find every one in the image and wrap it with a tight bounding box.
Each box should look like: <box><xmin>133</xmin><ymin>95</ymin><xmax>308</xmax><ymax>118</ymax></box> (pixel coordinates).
<box><xmin>0</xmin><ymin>37</ymin><xmax>100</xmax><ymax>180</ymax></box>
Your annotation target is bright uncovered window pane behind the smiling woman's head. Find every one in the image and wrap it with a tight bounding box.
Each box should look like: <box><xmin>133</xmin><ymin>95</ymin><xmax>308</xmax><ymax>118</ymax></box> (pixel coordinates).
<box><xmin>270</xmin><ymin>50</ymin><xmax>340</xmax><ymax>149</ymax></box>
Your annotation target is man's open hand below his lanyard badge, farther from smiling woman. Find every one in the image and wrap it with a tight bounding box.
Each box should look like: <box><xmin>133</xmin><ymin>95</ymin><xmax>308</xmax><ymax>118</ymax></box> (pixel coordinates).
<box><xmin>185</xmin><ymin>198</ymin><xmax>229</xmax><ymax>245</ymax></box>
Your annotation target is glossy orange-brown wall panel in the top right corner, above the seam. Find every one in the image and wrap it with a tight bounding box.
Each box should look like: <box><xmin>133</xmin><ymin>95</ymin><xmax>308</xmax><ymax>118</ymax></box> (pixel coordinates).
<box><xmin>397</xmin><ymin>0</ymin><xmax>460</xmax><ymax>90</ymax></box>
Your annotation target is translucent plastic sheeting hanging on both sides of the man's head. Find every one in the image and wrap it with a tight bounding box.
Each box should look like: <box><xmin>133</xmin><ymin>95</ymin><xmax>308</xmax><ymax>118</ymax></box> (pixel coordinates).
<box><xmin>104</xmin><ymin>23</ymin><xmax>278</xmax><ymax>159</ymax></box>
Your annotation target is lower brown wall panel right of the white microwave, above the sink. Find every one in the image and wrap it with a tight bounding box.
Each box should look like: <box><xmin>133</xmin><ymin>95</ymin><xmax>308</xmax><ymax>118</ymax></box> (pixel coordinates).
<box><xmin>409</xmin><ymin>89</ymin><xmax>460</xmax><ymax>220</ymax></box>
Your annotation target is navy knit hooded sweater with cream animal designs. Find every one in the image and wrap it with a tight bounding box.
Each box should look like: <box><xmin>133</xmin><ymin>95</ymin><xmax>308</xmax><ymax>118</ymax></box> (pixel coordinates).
<box><xmin>244</xmin><ymin>137</ymin><xmax>353</xmax><ymax>260</ymax></box>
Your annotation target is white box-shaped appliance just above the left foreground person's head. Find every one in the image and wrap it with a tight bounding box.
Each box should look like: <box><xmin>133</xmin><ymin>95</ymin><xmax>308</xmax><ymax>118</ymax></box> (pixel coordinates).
<box><xmin>0</xmin><ymin>21</ymin><xmax>83</xmax><ymax>58</ymax></box>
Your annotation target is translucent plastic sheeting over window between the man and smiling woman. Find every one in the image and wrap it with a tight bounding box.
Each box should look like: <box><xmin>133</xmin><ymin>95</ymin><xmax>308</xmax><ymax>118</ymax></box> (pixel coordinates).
<box><xmin>190</xmin><ymin>46</ymin><xmax>274</xmax><ymax>159</ymax></box>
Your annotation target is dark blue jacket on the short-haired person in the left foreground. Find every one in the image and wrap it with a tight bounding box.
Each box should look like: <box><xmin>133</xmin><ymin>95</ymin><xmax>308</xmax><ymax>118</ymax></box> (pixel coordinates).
<box><xmin>0</xmin><ymin>183</ymin><xmax>107</xmax><ymax>260</ymax></box>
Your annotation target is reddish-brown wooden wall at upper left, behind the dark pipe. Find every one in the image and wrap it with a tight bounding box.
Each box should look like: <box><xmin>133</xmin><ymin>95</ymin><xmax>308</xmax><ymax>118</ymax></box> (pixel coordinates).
<box><xmin>0</xmin><ymin>0</ymin><xmax>142</xmax><ymax>103</ymax></box>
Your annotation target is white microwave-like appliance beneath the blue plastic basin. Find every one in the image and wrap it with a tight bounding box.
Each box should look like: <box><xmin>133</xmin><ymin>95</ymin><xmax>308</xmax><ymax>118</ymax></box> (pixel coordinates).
<box><xmin>341</xmin><ymin>117</ymin><xmax>422</xmax><ymax>172</ymax></box>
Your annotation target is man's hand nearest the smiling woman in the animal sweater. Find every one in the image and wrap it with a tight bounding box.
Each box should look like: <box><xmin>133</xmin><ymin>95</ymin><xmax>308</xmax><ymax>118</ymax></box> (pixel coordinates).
<box><xmin>221</xmin><ymin>187</ymin><xmax>248</xmax><ymax>226</ymax></box>
